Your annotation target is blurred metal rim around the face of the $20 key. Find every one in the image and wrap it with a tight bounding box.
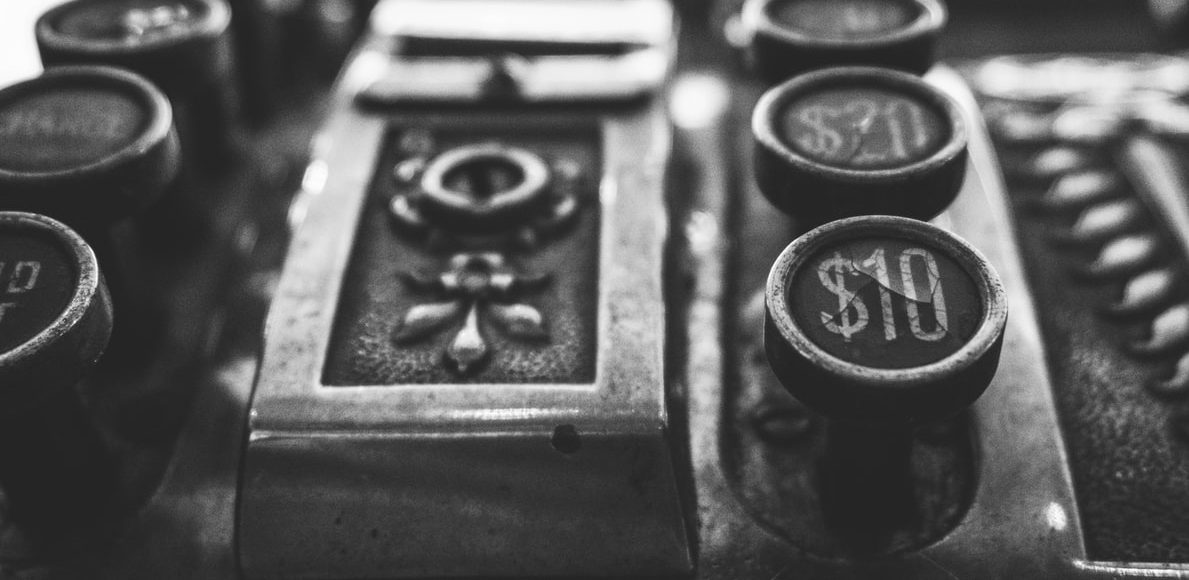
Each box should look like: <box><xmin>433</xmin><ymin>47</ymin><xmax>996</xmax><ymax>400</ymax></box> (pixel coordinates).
<box><xmin>751</xmin><ymin>67</ymin><xmax>967</xmax><ymax>183</ymax></box>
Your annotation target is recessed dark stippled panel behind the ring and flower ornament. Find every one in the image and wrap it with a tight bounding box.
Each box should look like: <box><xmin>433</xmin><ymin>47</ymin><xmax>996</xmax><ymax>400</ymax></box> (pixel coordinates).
<box><xmin>323</xmin><ymin>123</ymin><xmax>602</xmax><ymax>385</ymax></box>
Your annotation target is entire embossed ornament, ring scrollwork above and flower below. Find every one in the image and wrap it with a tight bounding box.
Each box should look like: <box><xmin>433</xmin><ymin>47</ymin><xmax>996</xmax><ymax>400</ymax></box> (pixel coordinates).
<box><xmin>386</xmin><ymin>131</ymin><xmax>581</xmax><ymax>376</ymax></box>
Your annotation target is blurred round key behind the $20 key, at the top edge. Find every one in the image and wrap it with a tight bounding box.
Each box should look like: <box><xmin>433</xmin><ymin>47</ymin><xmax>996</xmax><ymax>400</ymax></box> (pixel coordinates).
<box><xmin>743</xmin><ymin>0</ymin><xmax>946</xmax><ymax>82</ymax></box>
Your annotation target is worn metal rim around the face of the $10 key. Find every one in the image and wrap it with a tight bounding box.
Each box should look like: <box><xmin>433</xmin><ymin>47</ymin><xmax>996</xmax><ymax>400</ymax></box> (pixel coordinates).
<box><xmin>765</xmin><ymin>215</ymin><xmax>1007</xmax><ymax>387</ymax></box>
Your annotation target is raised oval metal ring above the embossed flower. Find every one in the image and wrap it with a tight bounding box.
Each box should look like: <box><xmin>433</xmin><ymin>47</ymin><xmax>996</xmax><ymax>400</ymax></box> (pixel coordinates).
<box><xmin>421</xmin><ymin>144</ymin><xmax>549</xmax><ymax>218</ymax></box>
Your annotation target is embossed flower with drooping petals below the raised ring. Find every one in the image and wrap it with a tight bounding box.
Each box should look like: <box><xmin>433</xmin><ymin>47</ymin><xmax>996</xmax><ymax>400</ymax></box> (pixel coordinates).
<box><xmin>392</xmin><ymin>252</ymin><xmax>549</xmax><ymax>374</ymax></box>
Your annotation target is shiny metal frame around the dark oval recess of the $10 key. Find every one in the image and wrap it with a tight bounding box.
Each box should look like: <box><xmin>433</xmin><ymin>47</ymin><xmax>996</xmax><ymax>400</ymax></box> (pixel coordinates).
<box><xmin>690</xmin><ymin>65</ymin><xmax>1083</xmax><ymax>579</ymax></box>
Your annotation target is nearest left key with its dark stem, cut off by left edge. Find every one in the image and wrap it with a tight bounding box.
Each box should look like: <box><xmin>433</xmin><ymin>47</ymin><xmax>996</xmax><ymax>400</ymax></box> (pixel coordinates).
<box><xmin>0</xmin><ymin>212</ymin><xmax>117</xmax><ymax>531</ymax></box>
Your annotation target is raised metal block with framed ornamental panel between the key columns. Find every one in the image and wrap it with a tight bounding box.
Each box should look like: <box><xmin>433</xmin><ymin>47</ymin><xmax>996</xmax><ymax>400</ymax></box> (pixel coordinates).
<box><xmin>238</xmin><ymin>3</ymin><xmax>692</xmax><ymax>579</ymax></box>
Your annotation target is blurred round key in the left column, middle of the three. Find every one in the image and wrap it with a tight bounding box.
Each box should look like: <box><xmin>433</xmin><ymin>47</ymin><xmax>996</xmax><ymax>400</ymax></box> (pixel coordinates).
<box><xmin>0</xmin><ymin>67</ymin><xmax>178</xmax><ymax>225</ymax></box>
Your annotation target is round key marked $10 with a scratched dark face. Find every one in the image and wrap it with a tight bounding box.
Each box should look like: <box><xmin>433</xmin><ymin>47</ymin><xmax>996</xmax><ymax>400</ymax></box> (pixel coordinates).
<box><xmin>765</xmin><ymin>216</ymin><xmax>1007</xmax><ymax>428</ymax></box>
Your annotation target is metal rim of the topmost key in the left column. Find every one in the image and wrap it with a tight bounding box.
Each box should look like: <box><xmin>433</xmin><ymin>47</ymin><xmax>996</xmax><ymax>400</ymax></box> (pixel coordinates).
<box><xmin>37</xmin><ymin>0</ymin><xmax>231</xmax><ymax>55</ymax></box>
